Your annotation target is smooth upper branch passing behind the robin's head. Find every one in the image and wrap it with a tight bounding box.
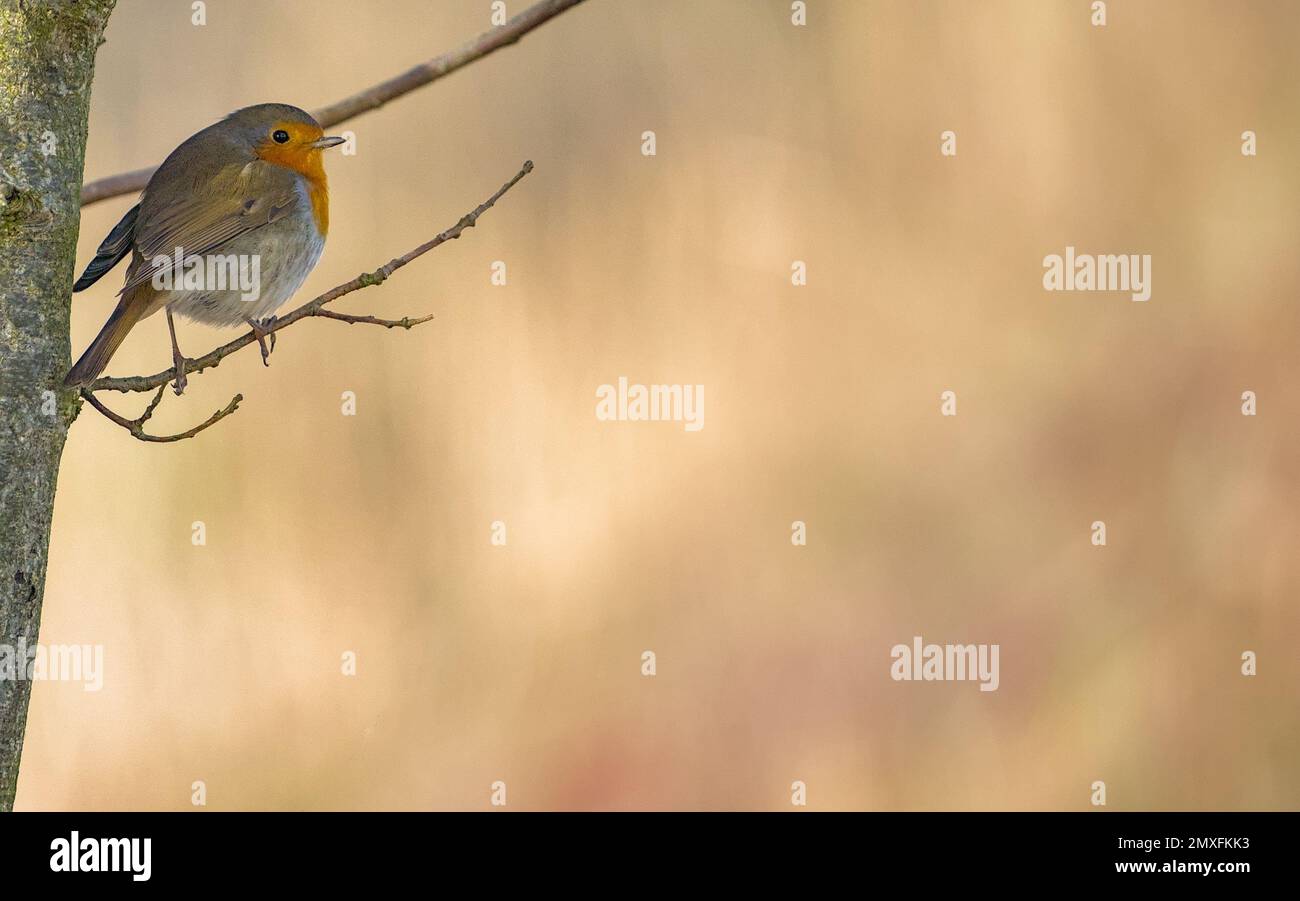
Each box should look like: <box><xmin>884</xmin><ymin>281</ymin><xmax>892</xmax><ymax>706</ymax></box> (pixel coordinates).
<box><xmin>82</xmin><ymin>0</ymin><xmax>582</xmax><ymax>207</ymax></box>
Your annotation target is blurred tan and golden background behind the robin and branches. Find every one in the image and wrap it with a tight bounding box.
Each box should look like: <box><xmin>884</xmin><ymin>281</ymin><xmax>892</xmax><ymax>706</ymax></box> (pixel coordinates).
<box><xmin>18</xmin><ymin>0</ymin><xmax>1300</xmax><ymax>810</ymax></box>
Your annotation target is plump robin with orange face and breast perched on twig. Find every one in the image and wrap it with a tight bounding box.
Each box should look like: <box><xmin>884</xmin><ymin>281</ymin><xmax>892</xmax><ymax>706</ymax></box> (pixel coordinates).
<box><xmin>64</xmin><ymin>103</ymin><xmax>345</xmax><ymax>394</ymax></box>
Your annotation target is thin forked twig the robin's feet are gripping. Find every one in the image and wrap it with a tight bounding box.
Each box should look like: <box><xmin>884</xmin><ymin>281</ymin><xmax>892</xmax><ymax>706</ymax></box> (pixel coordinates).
<box><xmin>92</xmin><ymin>160</ymin><xmax>533</xmax><ymax>392</ymax></box>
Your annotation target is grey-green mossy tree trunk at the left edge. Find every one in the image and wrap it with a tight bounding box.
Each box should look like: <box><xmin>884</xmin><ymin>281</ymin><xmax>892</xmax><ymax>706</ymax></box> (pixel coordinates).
<box><xmin>0</xmin><ymin>0</ymin><xmax>114</xmax><ymax>811</ymax></box>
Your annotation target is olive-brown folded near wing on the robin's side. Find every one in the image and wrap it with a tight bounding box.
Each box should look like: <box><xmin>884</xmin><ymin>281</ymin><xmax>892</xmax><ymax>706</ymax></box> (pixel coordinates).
<box><xmin>120</xmin><ymin>160</ymin><xmax>302</xmax><ymax>294</ymax></box>
